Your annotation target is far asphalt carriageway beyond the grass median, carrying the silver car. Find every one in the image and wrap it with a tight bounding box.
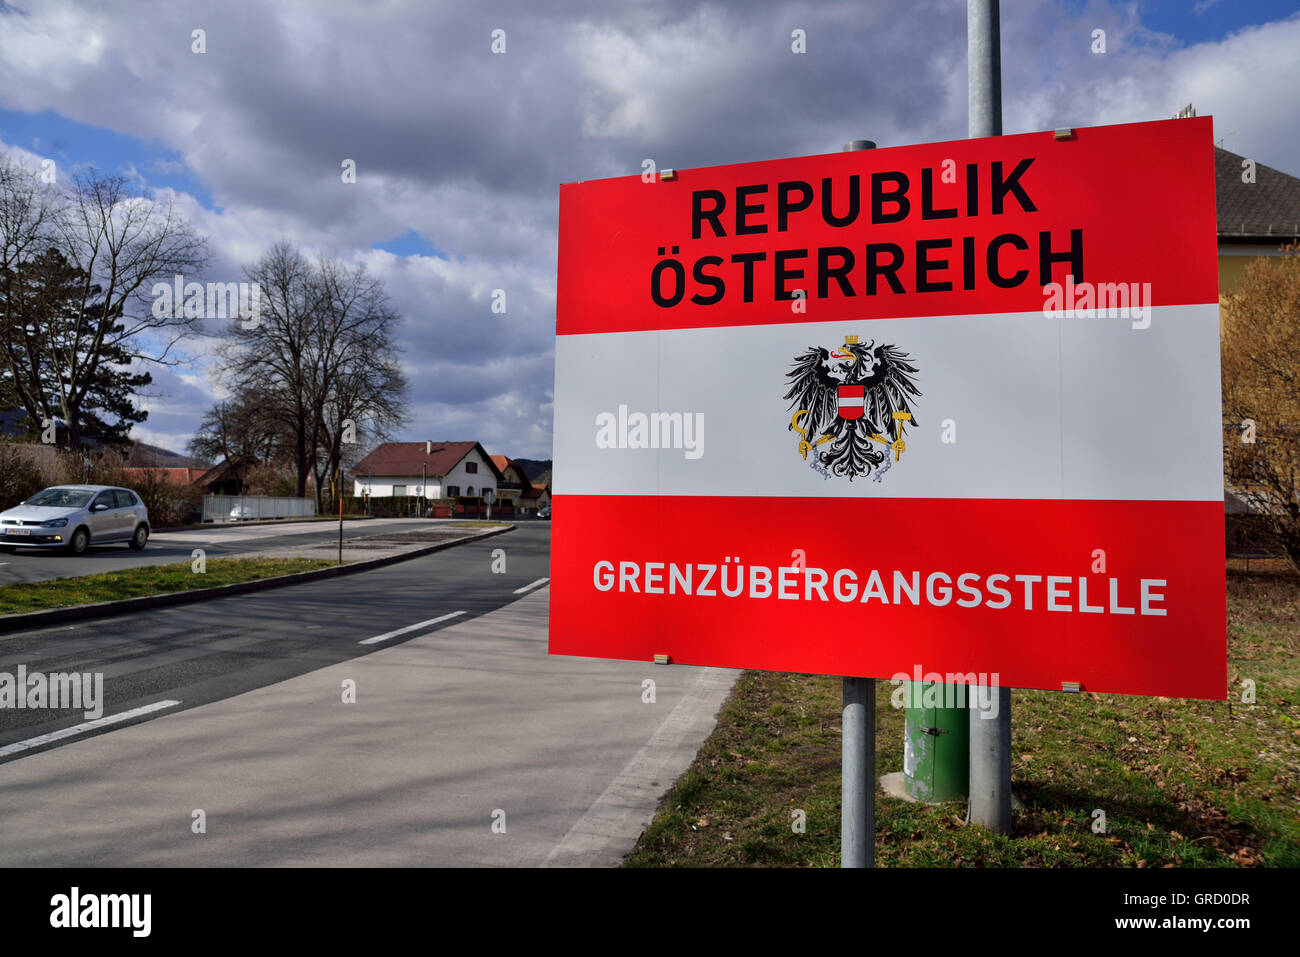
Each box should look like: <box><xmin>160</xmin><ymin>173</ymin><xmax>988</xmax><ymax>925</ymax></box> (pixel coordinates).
<box><xmin>0</xmin><ymin>519</ymin><xmax>530</xmax><ymax>585</ymax></box>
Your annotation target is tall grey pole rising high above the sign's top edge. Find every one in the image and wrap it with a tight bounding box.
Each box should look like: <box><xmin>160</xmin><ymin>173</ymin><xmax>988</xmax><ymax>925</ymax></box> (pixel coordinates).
<box><xmin>966</xmin><ymin>0</ymin><xmax>1011</xmax><ymax>833</ymax></box>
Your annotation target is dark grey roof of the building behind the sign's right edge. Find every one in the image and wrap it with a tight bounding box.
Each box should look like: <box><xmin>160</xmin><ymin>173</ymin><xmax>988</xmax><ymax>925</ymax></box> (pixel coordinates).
<box><xmin>1214</xmin><ymin>147</ymin><xmax>1300</xmax><ymax>244</ymax></box>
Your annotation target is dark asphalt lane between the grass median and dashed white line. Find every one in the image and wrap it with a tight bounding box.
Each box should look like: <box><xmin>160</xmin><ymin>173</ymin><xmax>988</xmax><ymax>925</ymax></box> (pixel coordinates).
<box><xmin>0</xmin><ymin>523</ymin><xmax>550</xmax><ymax>763</ymax></box>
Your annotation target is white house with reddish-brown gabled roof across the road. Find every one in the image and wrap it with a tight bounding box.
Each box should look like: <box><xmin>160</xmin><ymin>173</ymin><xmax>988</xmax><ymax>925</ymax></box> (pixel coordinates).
<box><xmin>351</xmin><ymin>442</ymin><xmax>504</xmax><ymax>498</ymax></box>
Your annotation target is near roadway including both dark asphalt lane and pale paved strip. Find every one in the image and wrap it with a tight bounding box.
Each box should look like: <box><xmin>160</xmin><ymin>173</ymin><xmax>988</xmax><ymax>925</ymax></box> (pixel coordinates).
<box><xmin>0</xmin><ymin>523</ymin><xmax>735</xmax><ymax>866</ymax></box>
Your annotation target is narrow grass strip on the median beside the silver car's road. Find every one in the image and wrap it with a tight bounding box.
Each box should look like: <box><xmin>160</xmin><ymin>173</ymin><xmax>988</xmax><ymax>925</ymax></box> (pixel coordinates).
<box><xmin>0</xmin><ymin>558</ymin><xmax>337</xmax><ymax>615</ymax></box>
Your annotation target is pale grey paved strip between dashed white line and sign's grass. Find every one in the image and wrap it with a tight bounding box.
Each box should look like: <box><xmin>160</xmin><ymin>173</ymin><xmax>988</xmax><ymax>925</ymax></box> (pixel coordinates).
<box><xmin>0</xmin><ymin>588</ymin><xmax>738</xmax><ymax>866</ymax></box>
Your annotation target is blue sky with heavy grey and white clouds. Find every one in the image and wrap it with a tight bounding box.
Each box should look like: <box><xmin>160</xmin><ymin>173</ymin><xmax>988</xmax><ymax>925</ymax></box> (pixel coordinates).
<box><xmin>0</xmin><ymin>0</ymin><xmax>1300</xmax><ymax>458</ymax></box>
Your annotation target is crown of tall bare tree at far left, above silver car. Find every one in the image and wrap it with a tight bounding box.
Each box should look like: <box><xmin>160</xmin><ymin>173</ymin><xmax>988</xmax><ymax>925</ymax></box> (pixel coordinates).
<box><xmin>0</xmin><ymin>163</ymin><xmax>207</xmax><ymax>449</ymax></box>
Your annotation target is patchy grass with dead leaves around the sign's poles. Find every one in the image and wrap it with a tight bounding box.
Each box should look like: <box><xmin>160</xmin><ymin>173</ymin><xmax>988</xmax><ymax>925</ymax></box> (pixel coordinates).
<box><xmin>624</xmin><ymin>562</ymin><xmax>1300</xmax><ymax>867</ymax></box>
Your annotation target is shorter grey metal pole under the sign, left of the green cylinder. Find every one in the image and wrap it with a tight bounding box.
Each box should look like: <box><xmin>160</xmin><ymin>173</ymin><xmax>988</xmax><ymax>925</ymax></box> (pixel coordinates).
<box><xmin>840</xmin><ymin>132</ymin><xmax>876</xmax><ymax>867</ymax></box>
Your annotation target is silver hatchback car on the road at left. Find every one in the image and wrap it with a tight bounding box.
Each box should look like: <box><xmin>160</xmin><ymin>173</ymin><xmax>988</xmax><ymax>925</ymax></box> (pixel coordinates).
<box><xmin>0</xmin><ymin>485</ymin><xmax>150</xmax><ymax>555</ymax></box>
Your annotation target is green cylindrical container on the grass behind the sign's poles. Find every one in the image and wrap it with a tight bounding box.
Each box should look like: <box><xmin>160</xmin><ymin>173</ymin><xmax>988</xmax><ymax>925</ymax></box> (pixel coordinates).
<box><xmin>902</xmin><ymin>681</ymin><xmax>970</xmax><ymax>804</ymax></box>
